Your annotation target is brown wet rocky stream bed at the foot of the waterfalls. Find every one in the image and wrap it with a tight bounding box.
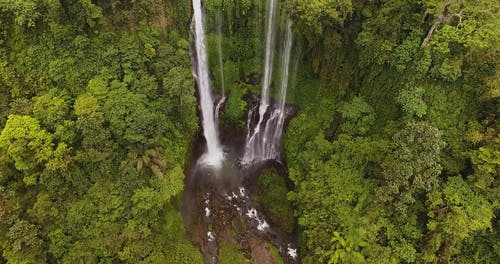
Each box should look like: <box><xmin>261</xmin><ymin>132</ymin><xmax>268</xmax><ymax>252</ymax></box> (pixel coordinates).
<box><xmin>182</xmin><ymin>144</ymin><xmax>300</xmax><ymax>264</ymax></box>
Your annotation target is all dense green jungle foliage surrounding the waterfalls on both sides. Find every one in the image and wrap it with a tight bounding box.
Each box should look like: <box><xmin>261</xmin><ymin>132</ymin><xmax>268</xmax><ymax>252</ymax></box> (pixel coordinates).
<box><xmin>0</xmin><ymin>0</ymin><xmax>500</xmax><ymax>264</ymax></box>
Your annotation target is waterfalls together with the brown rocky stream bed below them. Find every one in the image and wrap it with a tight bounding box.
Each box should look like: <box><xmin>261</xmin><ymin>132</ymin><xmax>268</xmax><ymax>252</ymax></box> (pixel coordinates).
<box><xmin>186</xmin><ymin>0</ymin><xmax>300</xmax><ymax>264</ymax></box>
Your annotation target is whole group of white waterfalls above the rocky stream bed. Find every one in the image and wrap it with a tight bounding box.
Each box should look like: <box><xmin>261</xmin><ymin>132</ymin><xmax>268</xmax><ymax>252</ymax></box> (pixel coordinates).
<box><xmin>192</xmin><ymin>0</ymin><xmax>293</xmax><ymax>167</ymax></box>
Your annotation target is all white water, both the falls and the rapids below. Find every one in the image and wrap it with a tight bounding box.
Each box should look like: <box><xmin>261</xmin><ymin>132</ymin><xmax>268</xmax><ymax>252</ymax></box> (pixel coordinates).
<box><xmin>188</xmin><ymin>0</ymin><xmax>297</xmax><ymax>263</ymax></box>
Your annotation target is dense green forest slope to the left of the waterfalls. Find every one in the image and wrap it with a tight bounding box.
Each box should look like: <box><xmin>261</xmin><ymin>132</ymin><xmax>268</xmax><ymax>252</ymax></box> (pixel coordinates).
<box><xmin>0</xmin><ymin>0</ymin><xmax>202</xmax><ymax>263</ymax></box>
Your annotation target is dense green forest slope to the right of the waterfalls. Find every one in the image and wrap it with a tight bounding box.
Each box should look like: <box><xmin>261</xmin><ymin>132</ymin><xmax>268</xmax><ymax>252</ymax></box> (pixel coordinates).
<box><xmin>286</xmin><ymin>0</ymin><xmax>500</xmax><ymax>263</ymax></box>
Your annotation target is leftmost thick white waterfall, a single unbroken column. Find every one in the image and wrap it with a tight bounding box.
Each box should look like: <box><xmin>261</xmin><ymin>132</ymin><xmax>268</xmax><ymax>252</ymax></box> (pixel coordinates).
<box><xmin>193</xmin><ymin>0</ymin><xmax>224</xmax><ymax>167</ymax></box>
